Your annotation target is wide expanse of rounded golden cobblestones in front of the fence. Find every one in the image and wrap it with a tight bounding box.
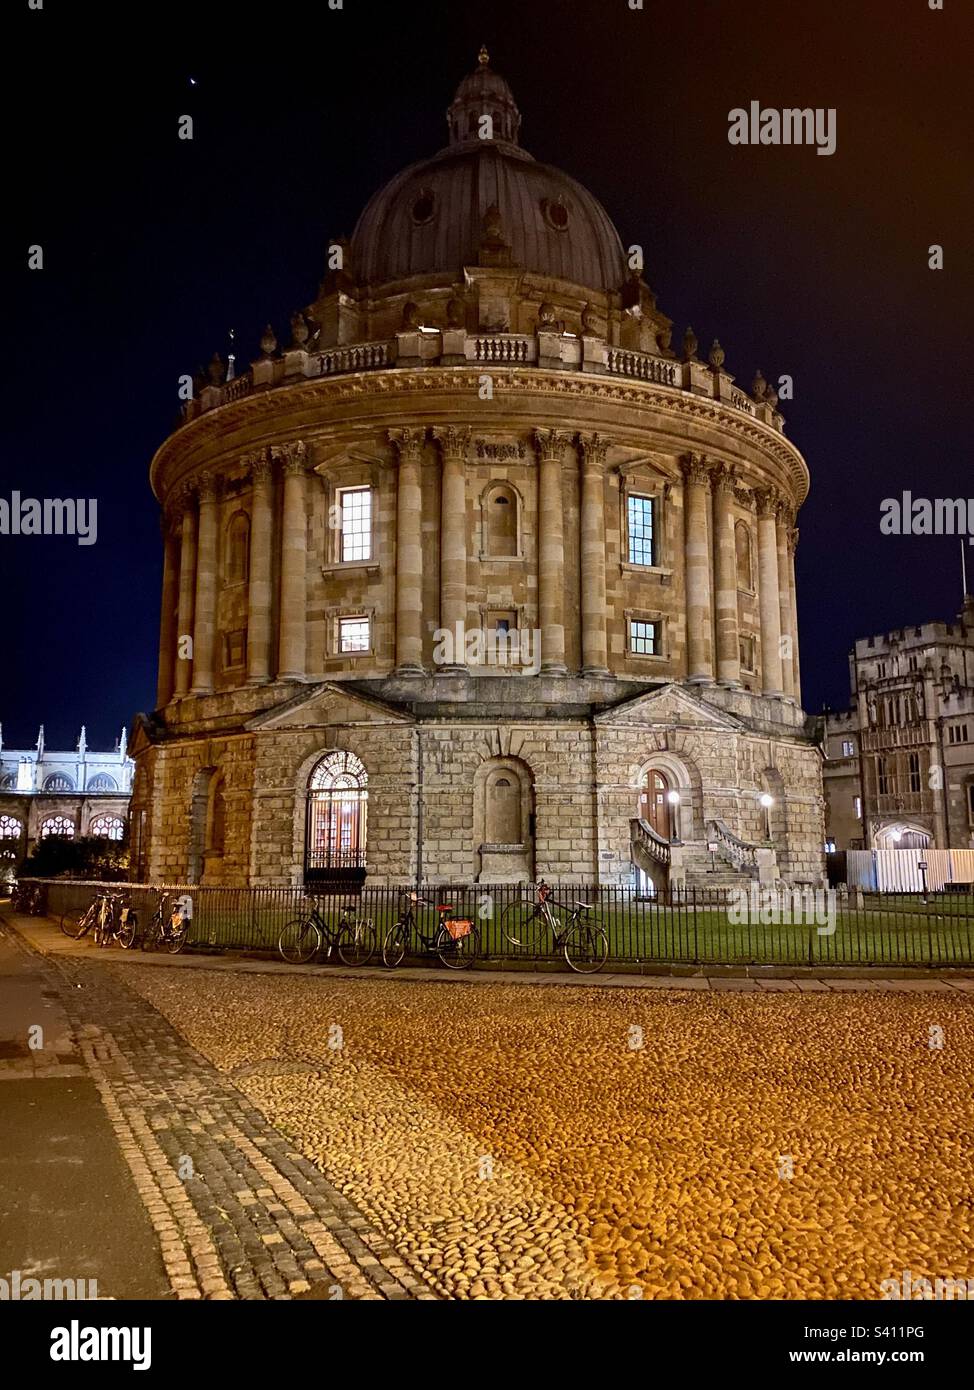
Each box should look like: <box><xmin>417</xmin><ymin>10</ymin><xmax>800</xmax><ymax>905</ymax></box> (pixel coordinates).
<box><xmin>119</xmin><ymin>962</ymin><xmax>974</xmax><ymax>1300</ymax></box>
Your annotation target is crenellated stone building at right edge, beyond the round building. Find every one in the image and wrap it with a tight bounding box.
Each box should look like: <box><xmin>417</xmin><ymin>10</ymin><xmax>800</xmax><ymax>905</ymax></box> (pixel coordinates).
<box><xmin>823</xmin><ymin>595</ymin><xmax>974</xmax><ymax>849</ymax></box>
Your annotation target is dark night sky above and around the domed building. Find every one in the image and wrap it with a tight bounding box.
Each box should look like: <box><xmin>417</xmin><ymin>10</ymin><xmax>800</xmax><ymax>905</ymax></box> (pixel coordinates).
<box><xmin>0</xmin><ymin>0</ymin><xmax>974</xmax><ymax>746</ymax></box>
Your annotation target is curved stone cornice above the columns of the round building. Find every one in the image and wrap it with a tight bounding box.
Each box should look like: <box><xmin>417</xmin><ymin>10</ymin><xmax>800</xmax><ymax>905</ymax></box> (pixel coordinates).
<box><xmin>150</xmin><ymin>366</ymin><xmax>809</xmax><ymax>506</ymax></box>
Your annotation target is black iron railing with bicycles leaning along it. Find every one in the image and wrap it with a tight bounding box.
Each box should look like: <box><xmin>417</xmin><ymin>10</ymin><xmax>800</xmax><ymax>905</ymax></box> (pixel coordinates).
<box><xmin>11</xmin><ymin>878</ymin><xmax>974</xmax><ymax>970</ymax></box>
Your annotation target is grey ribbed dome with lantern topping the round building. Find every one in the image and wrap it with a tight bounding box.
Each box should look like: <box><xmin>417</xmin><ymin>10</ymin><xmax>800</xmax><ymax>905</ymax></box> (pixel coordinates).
<box><xmin>352</xmin><ymin>50</ymin><xmax>628</xmax><ymax>292</ymax></box>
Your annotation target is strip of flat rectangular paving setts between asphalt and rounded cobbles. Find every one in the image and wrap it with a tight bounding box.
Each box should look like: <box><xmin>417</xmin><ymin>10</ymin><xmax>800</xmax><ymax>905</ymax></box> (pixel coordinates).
<box><xmin>0</xmin><ymin>922</ymin><xmax>435</xmax><ymax>1300</ymax></box>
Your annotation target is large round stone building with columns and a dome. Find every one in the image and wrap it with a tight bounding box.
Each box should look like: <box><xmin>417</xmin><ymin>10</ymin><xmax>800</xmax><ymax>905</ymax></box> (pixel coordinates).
<box><xmin>132</xmin><ymin>51</ymin><xmax>824</xmax><ymax>887</ymax></box>
